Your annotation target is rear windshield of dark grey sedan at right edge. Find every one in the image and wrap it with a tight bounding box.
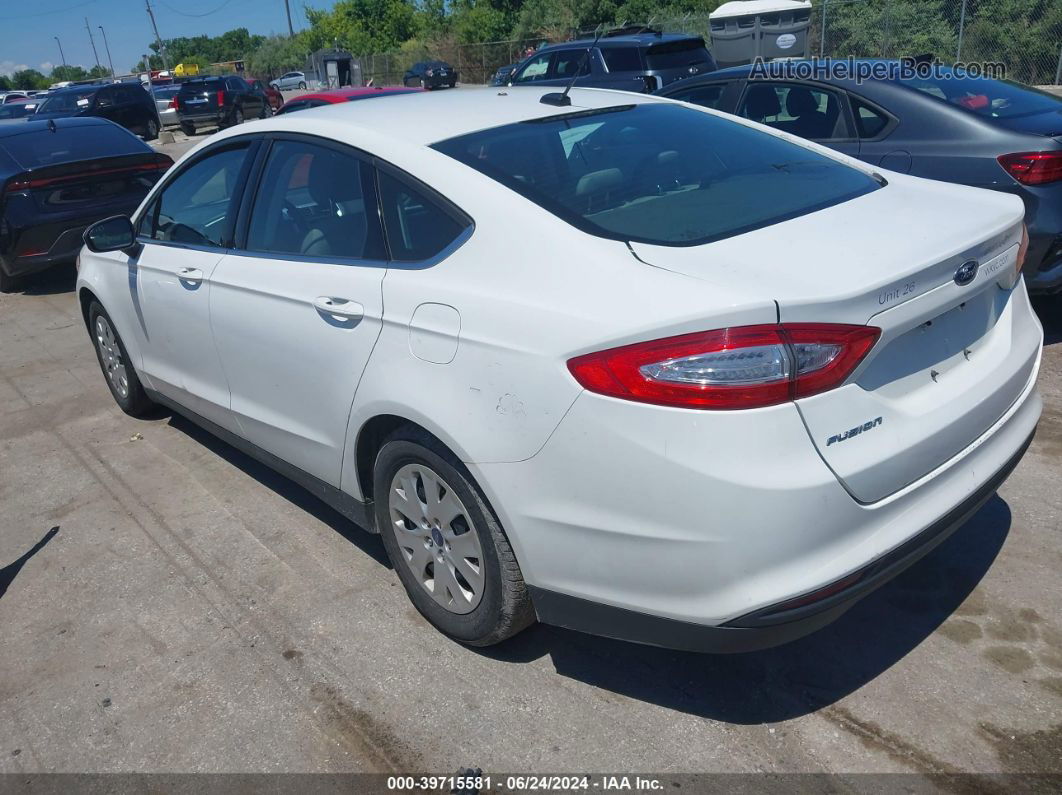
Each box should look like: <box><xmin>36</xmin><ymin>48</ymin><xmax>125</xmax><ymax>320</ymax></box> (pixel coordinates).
<box><xmin>897</xmin><ymin>72</ymin><xmax>1062</xmax><ymax>119</ymax></box>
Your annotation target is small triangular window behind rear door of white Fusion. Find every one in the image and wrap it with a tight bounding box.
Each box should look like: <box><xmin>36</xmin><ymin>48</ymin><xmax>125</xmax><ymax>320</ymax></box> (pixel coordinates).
<box><xmin>379</xmin><ymin>171</ymin><xmax>468</xmax><ymax>262</ymax></box>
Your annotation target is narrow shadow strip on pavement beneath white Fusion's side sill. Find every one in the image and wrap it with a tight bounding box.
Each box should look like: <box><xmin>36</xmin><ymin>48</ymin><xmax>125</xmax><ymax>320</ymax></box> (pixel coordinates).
<box><xmin>169</xmin><ymin>413</ymin><xmax>391</xmax><ymax>569</ymax></box>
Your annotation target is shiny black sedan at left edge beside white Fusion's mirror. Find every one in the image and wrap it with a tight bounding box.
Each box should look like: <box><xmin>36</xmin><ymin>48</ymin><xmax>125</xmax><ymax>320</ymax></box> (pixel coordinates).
<box><xmin>0</xmin><ymin>117</ymin><xmax>173</xmax><ymax>293</ymax></box>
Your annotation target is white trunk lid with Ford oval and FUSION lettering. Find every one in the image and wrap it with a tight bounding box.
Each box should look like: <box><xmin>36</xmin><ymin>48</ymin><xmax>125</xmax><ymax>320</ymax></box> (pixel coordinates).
<box><xmin>631</xmin><ymin>174</ymin><xmax>1040</xmax><ymax>503</ymax></box>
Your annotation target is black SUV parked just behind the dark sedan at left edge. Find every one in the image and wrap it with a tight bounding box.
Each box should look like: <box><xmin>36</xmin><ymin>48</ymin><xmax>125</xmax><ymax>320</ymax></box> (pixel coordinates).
<box><xmin>34</xmin><ymin>83</ymin><xmax>161</xmax><ymax>141</ymax></box>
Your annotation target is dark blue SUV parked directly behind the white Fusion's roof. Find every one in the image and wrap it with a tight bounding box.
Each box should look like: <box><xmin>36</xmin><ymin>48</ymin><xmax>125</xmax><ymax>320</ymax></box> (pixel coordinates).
<box><xmin>509</xmin><ymin>33</ymin><xmax>716</xmax><ymax>92</ymax></box>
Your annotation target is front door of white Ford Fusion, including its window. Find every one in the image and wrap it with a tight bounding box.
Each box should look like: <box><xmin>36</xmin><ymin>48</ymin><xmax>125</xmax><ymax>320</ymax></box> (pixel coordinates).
<box><xmin>135</xmin><ymin>139</ymin><xmax>256</xmax><ymax>430</ymax></box>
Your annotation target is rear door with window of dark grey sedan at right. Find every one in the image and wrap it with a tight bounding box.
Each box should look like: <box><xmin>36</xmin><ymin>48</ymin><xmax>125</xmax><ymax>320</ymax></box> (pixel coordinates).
<box><xmin>737</xmin><ymin>80</ymin><xmax>859</xmax><ymax>157</ymax></box>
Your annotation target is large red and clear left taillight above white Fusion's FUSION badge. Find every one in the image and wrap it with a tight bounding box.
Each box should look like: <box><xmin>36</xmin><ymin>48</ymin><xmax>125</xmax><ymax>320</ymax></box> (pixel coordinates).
<box><xmin>568</xmin><ymin>323</ymin><xmax>881</xmax><ymax>410</ymax></box>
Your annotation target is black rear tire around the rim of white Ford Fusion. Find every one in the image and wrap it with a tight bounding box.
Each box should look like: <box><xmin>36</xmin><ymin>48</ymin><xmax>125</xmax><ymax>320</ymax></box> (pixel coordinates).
<box><xmin>373</xmin><ymin>427</ymin><xmax>535</xmax><ymax>646</ymax></box>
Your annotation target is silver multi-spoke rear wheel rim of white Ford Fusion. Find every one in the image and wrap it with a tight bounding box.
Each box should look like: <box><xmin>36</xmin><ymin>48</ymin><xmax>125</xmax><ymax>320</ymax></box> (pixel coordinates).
<box><xmin>388</xmin><ymin>464</ymin><xmax>485</xmax><ymax>615</ymax></box>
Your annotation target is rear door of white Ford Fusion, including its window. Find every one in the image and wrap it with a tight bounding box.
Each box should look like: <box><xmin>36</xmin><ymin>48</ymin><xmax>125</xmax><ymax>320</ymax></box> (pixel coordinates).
<box><xmin>210</xmin><ymin>134</ymin><xmax>387</xmax><ymax>485</ymax></box>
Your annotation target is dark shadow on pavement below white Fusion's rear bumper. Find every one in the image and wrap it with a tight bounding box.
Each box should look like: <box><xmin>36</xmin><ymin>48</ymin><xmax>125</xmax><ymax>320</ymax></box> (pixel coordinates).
<box><xmin>474</xmin><ymin>497</ymin><xmax>1011</xmax><ymax>725</ymax></box>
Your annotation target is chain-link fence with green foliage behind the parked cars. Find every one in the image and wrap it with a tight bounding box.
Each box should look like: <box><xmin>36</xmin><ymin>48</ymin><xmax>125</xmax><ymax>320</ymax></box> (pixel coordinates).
<box><xmin>362</xmin><ymin>0</ymin><xmax>1062</xmax><ymax>85</ymax></box>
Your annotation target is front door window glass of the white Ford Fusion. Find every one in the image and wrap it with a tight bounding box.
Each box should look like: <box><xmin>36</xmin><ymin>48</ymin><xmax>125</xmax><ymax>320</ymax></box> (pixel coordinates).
<box><xmin>140</xmin><ymin>144</ymin><xmax>249</xmax><ymax>247</ymax></box>
